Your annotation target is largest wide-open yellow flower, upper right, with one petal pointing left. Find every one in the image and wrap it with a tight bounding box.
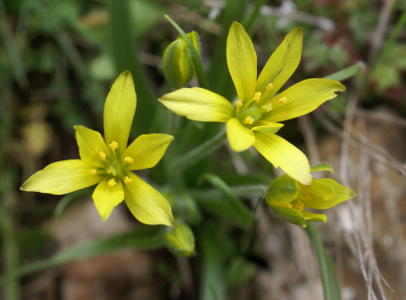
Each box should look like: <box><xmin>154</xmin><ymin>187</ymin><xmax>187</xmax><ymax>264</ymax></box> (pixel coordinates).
<box><xmin>159</xmin><ymin>22</ymin><xmax>345</xmax><ymax>185</ymax></box>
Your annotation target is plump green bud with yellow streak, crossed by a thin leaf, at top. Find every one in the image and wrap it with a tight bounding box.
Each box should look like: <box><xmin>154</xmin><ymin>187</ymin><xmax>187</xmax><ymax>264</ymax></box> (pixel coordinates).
<box><xmin>162</xmin><ymin>31</ymin><xmax>200</xmax><ymax>89</ymax></box>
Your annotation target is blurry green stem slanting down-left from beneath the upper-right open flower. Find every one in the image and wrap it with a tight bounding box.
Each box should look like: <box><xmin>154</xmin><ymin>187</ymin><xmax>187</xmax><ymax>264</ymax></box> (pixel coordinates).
<box><xmin>169</xmin><ymin>130</ymin><xmax>226</xmax><ymax>172</ymax></box>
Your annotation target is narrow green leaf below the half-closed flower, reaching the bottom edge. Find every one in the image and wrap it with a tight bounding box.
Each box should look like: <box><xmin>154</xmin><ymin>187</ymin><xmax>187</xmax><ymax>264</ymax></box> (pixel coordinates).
<box><xmin>305</xmin><ymin>222</ymin><xmax>341</xmax><ymax>300</ymax></box>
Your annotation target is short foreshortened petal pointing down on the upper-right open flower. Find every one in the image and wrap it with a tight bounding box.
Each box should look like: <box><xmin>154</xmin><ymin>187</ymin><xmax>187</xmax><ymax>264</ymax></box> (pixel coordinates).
<box><xmin>227</xmin><ymin>118</ymin><xmax>255</xmax><ymax>152</ymax></box>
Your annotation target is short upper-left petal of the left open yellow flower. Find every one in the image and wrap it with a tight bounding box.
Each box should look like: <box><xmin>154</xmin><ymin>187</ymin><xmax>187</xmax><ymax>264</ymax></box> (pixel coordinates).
<box><xmin>74</xmin><ymin>126</ymin><xmax>110</xmax><ymax>168</ymax></box>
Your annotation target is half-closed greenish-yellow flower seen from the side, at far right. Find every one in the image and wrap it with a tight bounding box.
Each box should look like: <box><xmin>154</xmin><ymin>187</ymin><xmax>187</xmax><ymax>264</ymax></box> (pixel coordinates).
<box><xmin>266</xmin><ymin>164</ymin><xmax>356</xmax><ymax>227</ymax></box>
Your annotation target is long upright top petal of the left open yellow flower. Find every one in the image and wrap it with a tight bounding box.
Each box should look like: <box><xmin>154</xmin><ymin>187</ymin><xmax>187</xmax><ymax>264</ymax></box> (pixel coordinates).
<box><xmin>103</xmin><ymin>71</ymin><xmax>137</xmax><ymax>157</ymax></box>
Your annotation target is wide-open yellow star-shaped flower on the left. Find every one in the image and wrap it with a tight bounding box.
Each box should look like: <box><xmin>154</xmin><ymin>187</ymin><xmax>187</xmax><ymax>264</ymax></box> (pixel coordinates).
<box><xmin>20</xmin><ymin>71</ymin><xmax>175</xmax><ymax>226</ymax></box>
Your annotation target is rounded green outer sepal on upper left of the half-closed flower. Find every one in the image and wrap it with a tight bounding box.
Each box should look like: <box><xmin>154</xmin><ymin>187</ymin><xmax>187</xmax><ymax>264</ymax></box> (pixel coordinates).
<box><xmin>266</xmin><ymin>175</ymin><xmax>300</xmax><ymax>204</ymax></box>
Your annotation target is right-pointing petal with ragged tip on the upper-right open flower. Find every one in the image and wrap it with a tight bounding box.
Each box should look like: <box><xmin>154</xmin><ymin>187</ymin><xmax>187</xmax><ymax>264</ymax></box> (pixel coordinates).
<box><xmin>261</xmin><ymin>78</ymin><xmax>345</xmax><ymax>122</ymax></box>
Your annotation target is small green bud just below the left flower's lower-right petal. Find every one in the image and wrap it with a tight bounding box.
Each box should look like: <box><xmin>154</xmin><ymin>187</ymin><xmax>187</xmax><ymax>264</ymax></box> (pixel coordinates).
<box><xmin>165</xmin><ymin>223</ymin><xmax>195</xmax><ymax>257</ymax></box>
